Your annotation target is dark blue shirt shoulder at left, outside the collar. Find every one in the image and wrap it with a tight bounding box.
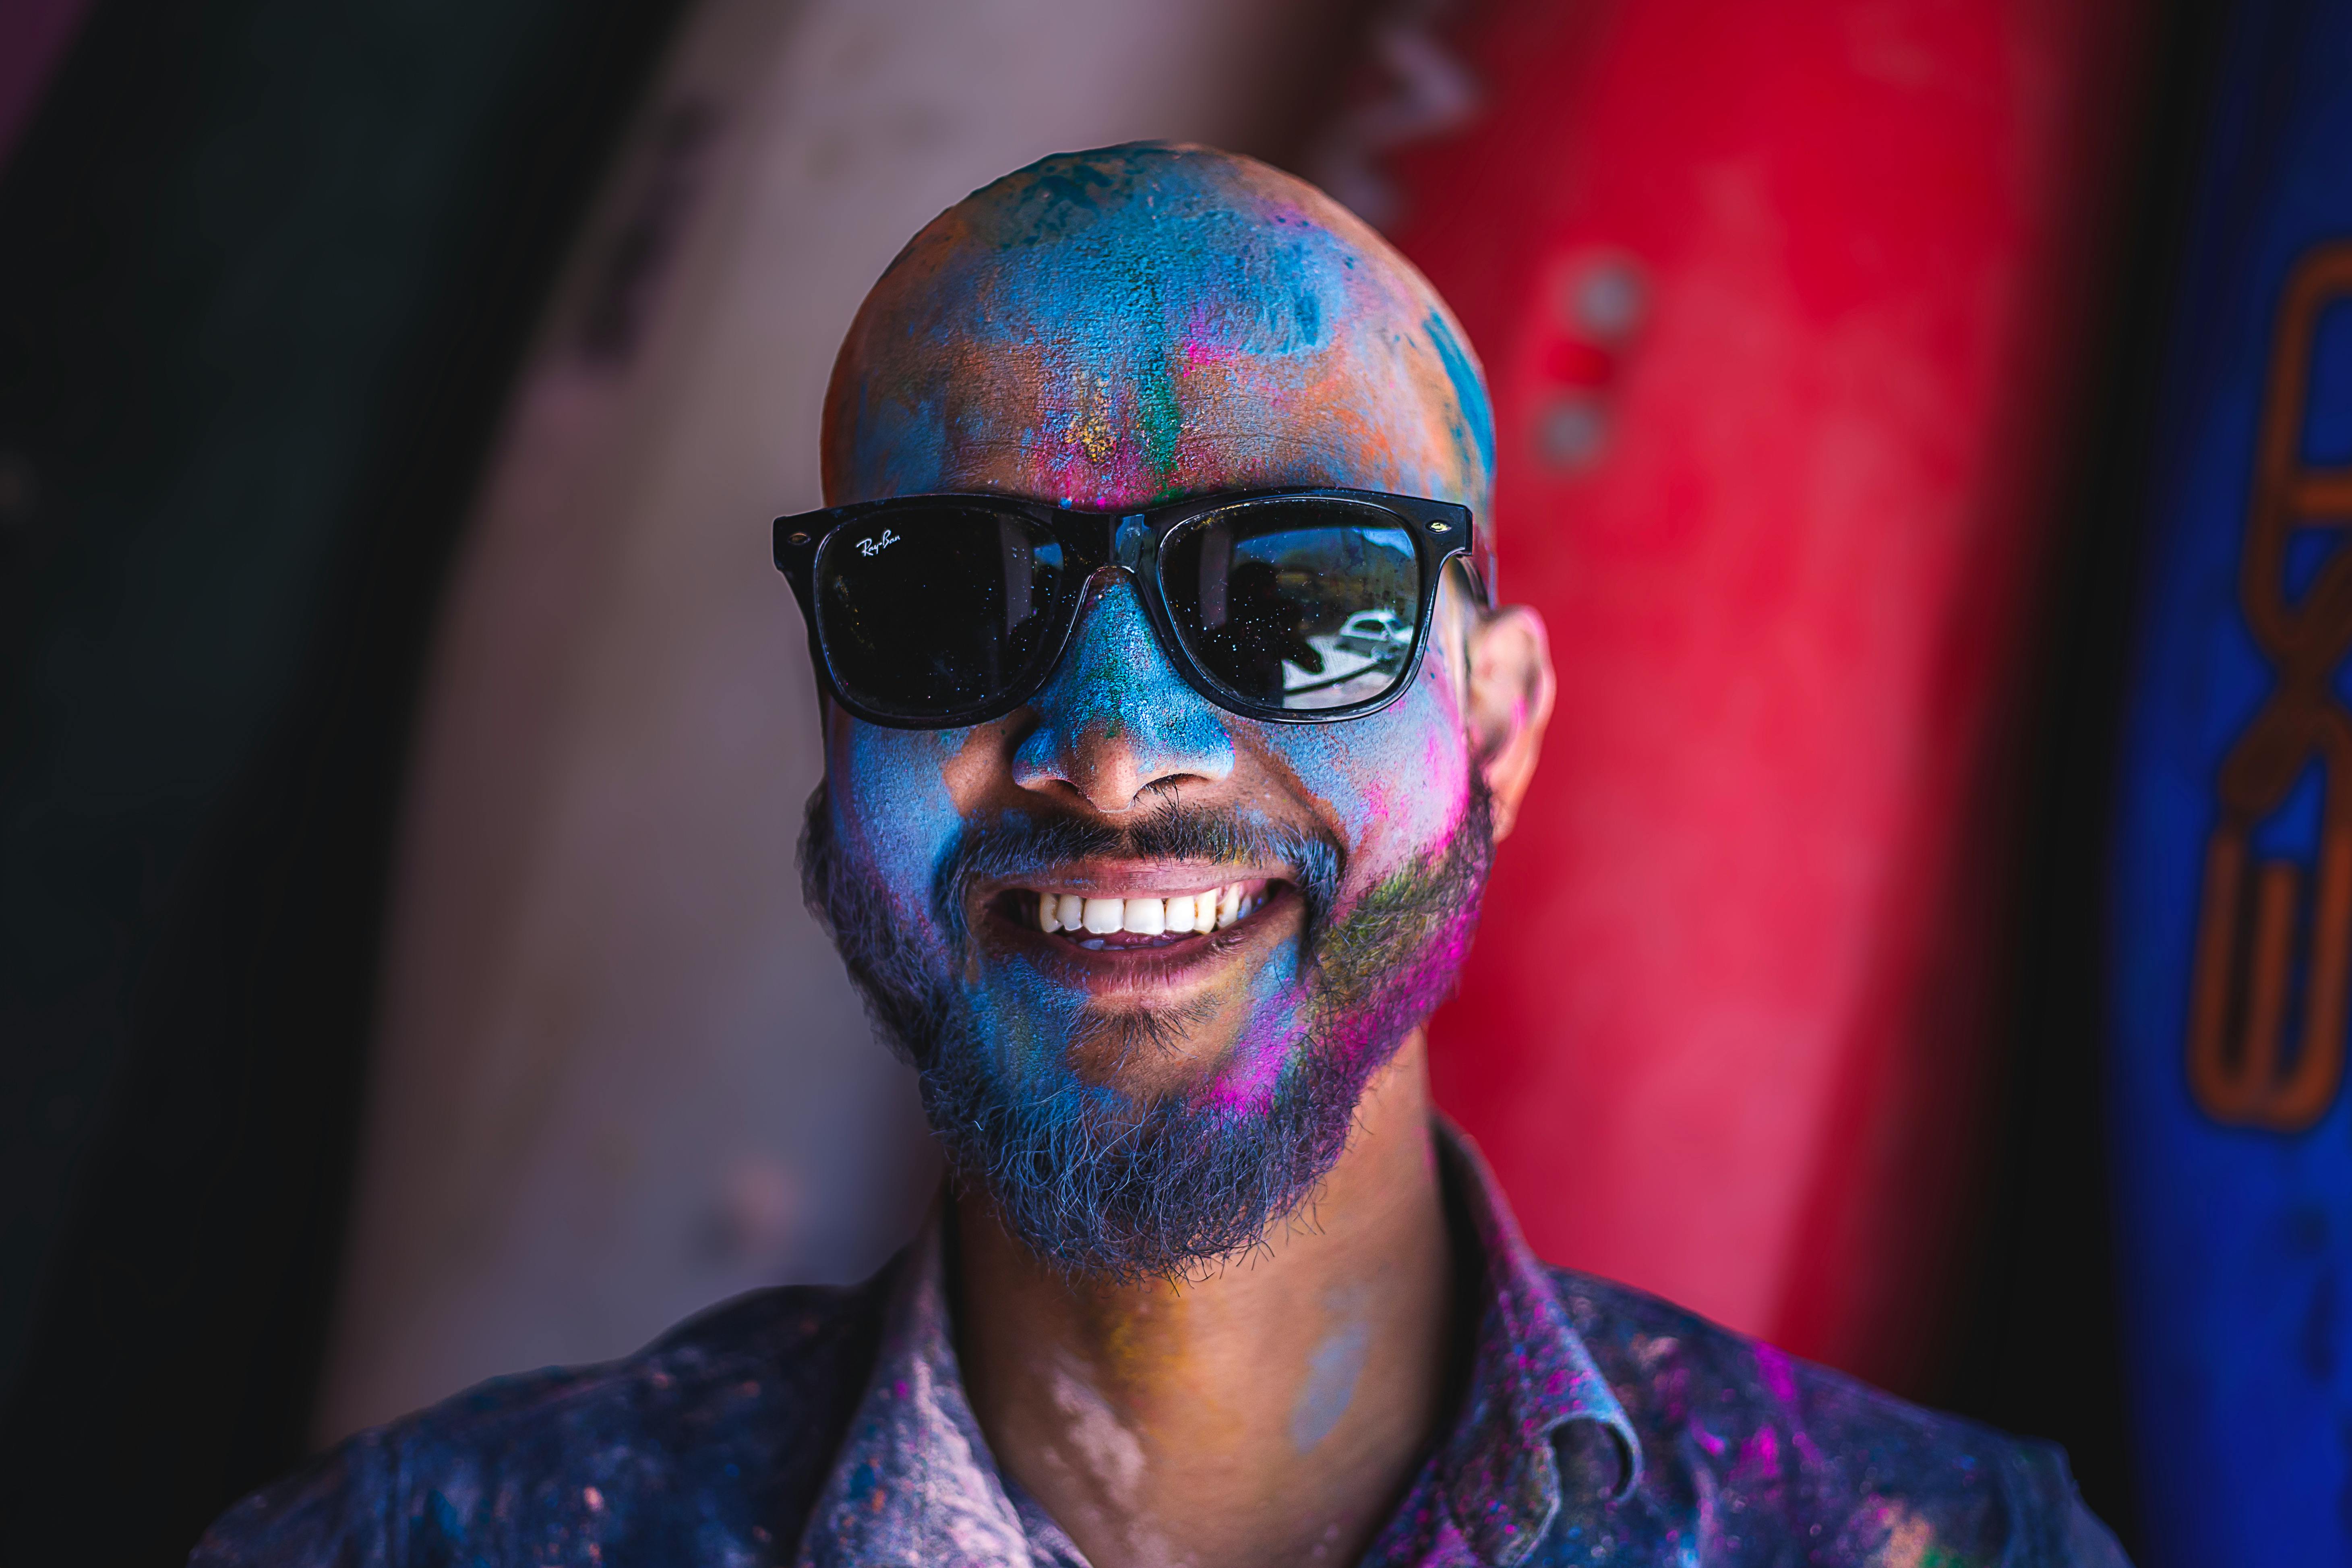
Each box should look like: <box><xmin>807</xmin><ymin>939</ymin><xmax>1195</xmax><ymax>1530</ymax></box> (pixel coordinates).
<box><xmin>190</xmin><ymin>1279</ymin><xmax>882</xmax><ymax>1568</ymax></box>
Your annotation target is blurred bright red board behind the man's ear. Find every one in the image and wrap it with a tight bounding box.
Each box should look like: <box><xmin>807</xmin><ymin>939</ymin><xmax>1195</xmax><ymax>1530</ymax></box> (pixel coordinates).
<box><xmin>1390</xmin><ymin>0</ymin><xmax>2147</xmax><ymax>1387</ymax></box>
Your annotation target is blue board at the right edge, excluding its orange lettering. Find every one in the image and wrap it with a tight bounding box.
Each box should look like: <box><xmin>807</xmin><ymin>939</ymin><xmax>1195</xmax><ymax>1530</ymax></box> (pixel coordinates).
<box><xmin>2110</xmin><ymin>0</ymin><xmax>2352</xmax><ymax>1568</ymax></box>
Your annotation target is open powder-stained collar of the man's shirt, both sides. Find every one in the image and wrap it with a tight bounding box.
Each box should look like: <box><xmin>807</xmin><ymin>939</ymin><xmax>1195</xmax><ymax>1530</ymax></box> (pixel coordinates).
<box><xmin>800</xmin><ymin>1119</ymin><xmax>1642</xmax><ymax>1568</ymax></box>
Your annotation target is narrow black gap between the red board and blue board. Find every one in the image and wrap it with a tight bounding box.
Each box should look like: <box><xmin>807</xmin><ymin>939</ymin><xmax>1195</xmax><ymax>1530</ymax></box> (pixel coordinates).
<box><xmin>1931</xmin><ymin>5</ymin><xmax>2225</xmax><ymax>1556</ymax></box>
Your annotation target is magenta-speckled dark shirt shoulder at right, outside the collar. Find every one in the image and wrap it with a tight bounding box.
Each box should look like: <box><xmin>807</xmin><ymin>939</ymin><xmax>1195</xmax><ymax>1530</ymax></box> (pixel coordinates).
<box><xmin>1550</xmin><ymin>1270</ymin><xmax>2124</xmax><ymax>1568</ymax></box>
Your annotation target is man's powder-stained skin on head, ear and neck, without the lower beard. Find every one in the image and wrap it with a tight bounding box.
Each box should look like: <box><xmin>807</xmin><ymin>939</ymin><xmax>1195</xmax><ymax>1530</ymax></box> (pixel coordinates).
<box><xmin>816</xmin><ymin>148</ymin><xmax>1550</xmax><ymax>1568</ymax></box>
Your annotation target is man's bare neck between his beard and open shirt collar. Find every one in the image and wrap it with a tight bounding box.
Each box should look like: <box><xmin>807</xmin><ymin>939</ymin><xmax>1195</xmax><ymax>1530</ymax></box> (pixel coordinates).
<box><xmin>957</xmin><ymin>1030</ymin><xmax>1454</xmax><ymax>1568</ymax></box>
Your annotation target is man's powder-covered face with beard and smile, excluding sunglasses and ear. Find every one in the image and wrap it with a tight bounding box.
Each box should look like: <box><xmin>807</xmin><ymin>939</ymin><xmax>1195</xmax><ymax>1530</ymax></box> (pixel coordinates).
<box><xmin>807</xmin><ymin>151</ymin><xmax>1491</xmax><ymax>1274</ymax></box>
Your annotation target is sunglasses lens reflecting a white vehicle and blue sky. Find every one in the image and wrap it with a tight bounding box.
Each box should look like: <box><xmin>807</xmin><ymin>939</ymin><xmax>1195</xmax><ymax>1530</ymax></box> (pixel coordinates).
<box><xmin>1160</xmin><ymin>499</ymin><xmax>1421</xmax><ymax>712</ymax></box>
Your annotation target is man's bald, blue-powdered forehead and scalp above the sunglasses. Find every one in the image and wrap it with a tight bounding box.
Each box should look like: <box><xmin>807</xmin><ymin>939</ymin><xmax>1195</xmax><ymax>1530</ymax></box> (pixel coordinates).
<box><xmin>825</xmin><ymin>148</ymin><xmax>1491</xmax><ymax>513</ymax></box>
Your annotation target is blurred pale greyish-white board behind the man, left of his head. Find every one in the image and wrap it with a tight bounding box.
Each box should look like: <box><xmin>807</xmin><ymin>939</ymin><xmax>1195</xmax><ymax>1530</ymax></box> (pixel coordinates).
<box><xmin>318</xmin><ymin>0</ymin><xmax>1357</xmax><ymax>1439</ymax></box>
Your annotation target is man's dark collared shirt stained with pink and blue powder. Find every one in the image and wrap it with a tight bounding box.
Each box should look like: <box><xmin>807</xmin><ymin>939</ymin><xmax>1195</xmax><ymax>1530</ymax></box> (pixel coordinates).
<box><xmin>193</xmin><ymin>1133</ymin><xmax>2129</xmax><ymax>1568</ymax></box>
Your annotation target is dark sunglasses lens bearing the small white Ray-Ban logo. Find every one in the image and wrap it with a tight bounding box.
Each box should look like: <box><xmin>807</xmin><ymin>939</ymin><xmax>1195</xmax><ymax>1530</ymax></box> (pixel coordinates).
<box><xmin>816</xmin><ymin>505</ymin><xmax>1070</xmax><ymax>724</ymax></box>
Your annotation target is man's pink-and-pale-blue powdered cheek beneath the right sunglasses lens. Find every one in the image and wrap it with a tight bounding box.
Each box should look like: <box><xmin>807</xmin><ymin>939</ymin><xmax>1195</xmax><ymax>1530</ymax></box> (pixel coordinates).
<box><xmin>1258</xmin><ymin>677</ymin><xmax>1470</xmax><ymax>891</ymax></box>
